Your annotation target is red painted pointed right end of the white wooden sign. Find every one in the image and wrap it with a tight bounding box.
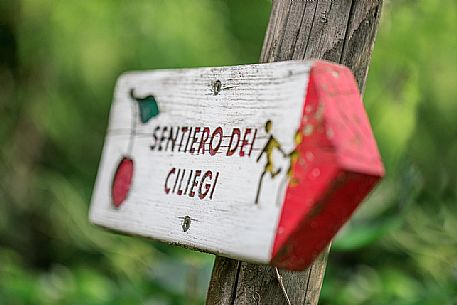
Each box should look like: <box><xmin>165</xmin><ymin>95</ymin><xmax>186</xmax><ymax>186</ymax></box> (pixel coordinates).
<box><xmin>272</xmin><ymin>61</ymin><xmax>384</xmax><ymax>270</ymax></box>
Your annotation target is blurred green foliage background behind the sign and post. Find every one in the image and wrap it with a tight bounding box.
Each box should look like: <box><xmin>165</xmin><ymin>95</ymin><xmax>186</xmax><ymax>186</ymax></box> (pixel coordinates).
<box><xmin>0</xmin><ymin>0</ymin><xmax>457</xmax><ymax>305</ymax></box>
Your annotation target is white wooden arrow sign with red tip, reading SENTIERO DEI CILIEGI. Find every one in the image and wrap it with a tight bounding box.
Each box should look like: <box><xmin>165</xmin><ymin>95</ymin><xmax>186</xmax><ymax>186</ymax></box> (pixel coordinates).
<box><xmin>90</xmin><ymin>61</ymin><xmax>384</xmax><ymax>270</ymax></box>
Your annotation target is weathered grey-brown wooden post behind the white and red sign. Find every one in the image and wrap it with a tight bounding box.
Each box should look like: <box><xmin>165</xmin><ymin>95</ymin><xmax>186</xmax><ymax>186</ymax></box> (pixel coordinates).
<box><xmin>206</xmin><ymin>0</ymin><xmax>382</xmax><ymax>305</ymax></box>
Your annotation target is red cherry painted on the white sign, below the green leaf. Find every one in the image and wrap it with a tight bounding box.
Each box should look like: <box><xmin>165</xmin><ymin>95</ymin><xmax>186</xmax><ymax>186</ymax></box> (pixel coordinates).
<box><xmin>111</xmin><ymin>157</ymin><xmax>133</xmax><ymax>208</ymax></box>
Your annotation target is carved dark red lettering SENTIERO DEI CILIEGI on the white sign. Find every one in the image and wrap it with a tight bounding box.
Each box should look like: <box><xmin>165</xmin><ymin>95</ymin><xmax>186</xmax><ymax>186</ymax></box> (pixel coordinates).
<box><xmin>149</xmin><ymin>126</ymin><xmax>258</xmax><ymax>200</ymax></box>
